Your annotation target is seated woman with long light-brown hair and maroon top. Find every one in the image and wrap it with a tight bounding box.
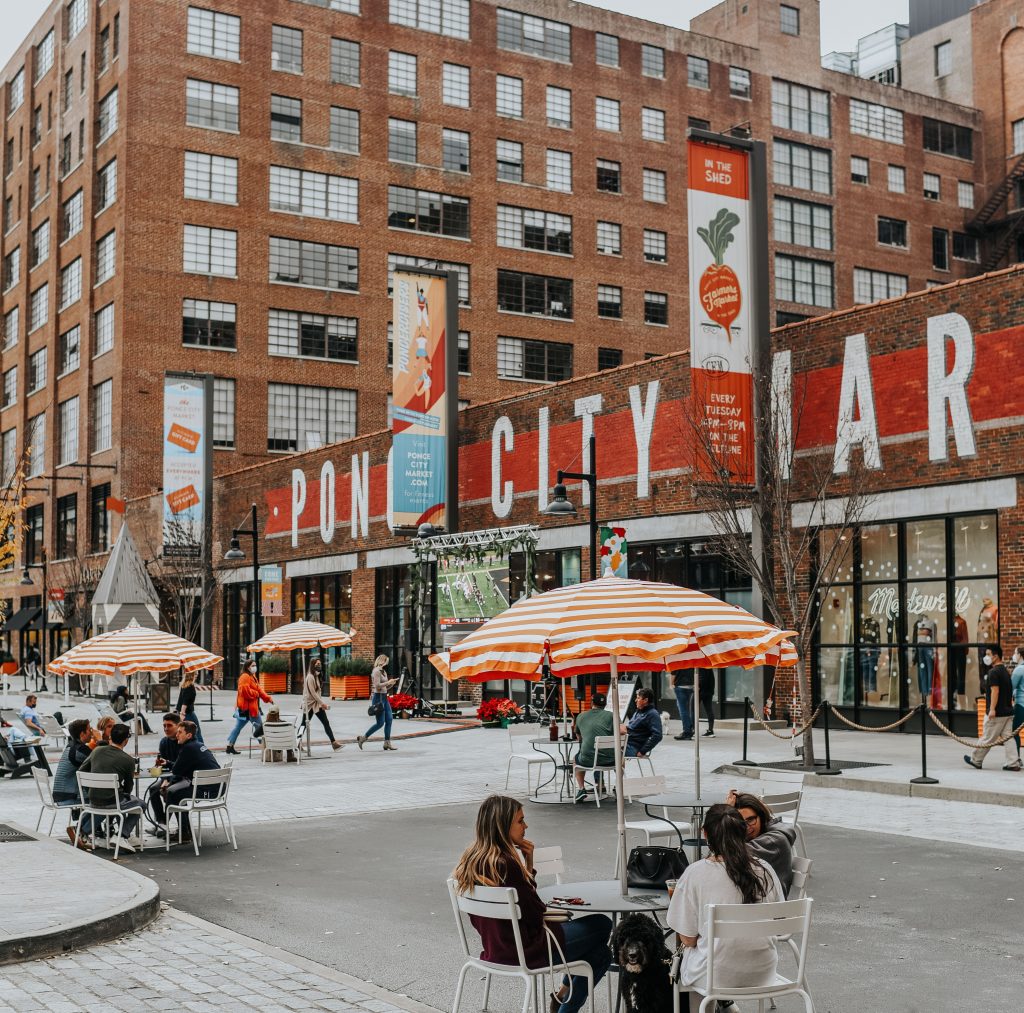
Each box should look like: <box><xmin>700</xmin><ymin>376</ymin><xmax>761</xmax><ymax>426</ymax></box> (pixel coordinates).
<box><xmin>452</xmin><ymin>795</ymin><xmax>611</xmax><ymax>1013</ymax></box>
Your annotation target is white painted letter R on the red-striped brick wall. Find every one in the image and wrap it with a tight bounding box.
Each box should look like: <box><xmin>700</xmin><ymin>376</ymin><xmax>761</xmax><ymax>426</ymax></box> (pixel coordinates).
<box><xmin>928</xmin><ymin>313</ymin><xmax>976</xmax><ymax>461</ymax></box>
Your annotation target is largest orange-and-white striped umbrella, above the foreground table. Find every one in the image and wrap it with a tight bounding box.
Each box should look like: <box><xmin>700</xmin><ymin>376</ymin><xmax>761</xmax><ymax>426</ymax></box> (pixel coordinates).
<box><xmin>449</xmin><ymin>576</ymin><xmax>797</xmax><ymax>679</ymax></box>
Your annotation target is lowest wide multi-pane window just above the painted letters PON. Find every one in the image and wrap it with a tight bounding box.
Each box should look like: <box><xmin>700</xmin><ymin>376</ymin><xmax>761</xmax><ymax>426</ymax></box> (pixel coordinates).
<box><xmin>266</xmin><ymin>383</ymin><xmax>356</xmax><ymax>452</ymax></box>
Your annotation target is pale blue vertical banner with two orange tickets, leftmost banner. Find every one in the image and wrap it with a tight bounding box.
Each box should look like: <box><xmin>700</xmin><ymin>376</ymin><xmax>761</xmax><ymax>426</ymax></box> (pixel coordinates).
<box><xmin>163</xmin><ymin>373</ymin><xmax>212</xmax><ymax>557</ymax></box>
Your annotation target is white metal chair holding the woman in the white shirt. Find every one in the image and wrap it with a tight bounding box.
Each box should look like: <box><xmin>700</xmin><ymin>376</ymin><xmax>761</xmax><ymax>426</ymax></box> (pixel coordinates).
<box><xmin>673</xmin><ymin>897</ymin><xmax>814</xmax><ymax>1013</ymax></box>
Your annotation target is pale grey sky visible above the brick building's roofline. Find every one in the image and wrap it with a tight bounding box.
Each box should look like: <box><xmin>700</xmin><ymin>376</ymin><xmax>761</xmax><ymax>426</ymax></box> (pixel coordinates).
<box><xmin>0</xmin><ymin>0</ymin><xmax>907</xmax><ymax>67</ymax></box>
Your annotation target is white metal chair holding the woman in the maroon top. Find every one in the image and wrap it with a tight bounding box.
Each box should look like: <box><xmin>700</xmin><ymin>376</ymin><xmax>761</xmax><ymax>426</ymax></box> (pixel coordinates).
<box><xmin>447</xmin><ymin>879</ymin><xmax>597</xmax><ymax>1013</ymax></box>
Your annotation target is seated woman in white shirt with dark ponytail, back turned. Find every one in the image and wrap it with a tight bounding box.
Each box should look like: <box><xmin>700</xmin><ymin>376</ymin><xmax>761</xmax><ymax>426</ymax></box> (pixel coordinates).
<box><xmin>666</xmin><ymin>803</ymin><xmax>783</xmax><ymax>1010</ymax></box>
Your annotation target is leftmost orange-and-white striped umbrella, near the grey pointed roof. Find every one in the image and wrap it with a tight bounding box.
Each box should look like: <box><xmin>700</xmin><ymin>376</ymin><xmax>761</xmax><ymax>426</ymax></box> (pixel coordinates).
<box><xmin>47</xmin><ymin>620</ymin><xmax>223</xmax><ymax>676</ymax></box>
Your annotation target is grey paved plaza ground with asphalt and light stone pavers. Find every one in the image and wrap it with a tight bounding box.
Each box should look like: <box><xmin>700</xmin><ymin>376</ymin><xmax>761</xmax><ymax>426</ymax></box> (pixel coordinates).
<box><xmin>0</xmin><ymin>693</ymin><xmax>1024</xmax><ymax>1013</ymax></box>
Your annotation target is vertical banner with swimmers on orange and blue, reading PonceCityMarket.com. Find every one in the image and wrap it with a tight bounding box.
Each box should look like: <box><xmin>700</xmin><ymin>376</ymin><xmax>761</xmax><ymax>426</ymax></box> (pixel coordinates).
<box><xmin>391</xmin><ymin>268</ymin><xmax>459</xmax><ymax>531</ymax></box>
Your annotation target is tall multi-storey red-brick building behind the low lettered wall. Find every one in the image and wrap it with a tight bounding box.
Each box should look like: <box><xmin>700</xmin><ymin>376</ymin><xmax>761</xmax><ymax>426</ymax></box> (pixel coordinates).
<box><xmin>0</xmin><ymin>0</ymin><xmax>1007</xmax><ymax>676</ymax></box>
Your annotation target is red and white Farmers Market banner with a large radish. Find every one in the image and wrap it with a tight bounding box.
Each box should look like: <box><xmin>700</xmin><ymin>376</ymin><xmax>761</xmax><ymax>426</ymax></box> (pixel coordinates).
<box><xmin>686</xmin><ymin>138</ymin><xmax>756</xmax><ymax>484</ymax></box>
